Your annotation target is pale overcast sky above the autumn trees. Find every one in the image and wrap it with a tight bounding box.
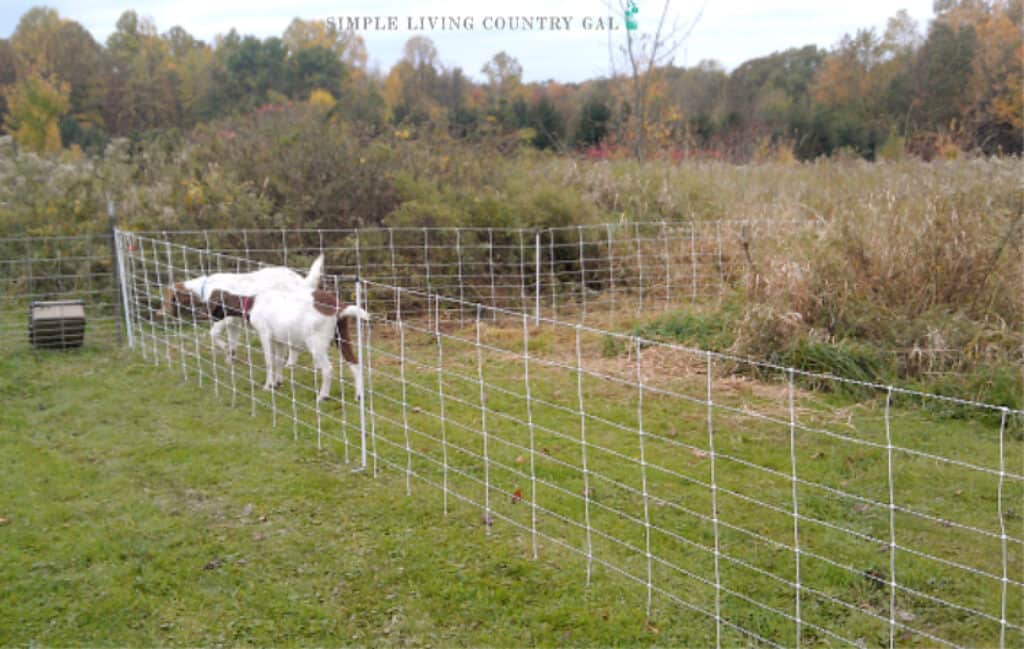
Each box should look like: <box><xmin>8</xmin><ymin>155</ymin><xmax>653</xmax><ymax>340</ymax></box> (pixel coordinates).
<box><xmin>0</xmin><ymin>0</ymin><xmax>933</xmax><ymax>81</ymax></box>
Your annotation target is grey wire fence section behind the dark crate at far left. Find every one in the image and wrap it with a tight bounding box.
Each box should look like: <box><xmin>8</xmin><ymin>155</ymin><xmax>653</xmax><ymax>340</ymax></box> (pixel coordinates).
<box><xmin>0</xmin><ymin>234</ymin><xmax>123</xmax><ymax>353</ymax></box>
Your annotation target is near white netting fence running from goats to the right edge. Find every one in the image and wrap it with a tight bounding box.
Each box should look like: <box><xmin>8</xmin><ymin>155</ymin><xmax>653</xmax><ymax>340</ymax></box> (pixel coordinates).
<box><xmin>119</xmin><ymin>228</ymin><xmax>1024</xmax><ymax>647</ymax></box>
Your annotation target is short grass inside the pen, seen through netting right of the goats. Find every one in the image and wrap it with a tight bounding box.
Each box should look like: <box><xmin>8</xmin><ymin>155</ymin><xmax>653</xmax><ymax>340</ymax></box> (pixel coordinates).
<box><xmin>362</xmin><ymin>319</ymin><xmax>1024</xmax><ymax>645</ymax></box>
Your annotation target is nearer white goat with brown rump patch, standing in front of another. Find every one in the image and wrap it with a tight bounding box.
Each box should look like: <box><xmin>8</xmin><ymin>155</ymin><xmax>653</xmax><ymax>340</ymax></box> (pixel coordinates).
<box><xmin>208</xmin><ymin>290</ymin><xmax>370</xmax><ymax>401</ymax></box>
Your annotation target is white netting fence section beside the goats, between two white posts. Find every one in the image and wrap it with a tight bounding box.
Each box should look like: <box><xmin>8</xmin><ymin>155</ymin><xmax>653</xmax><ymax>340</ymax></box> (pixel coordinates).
<box><xmin>118</xmin><ymin>232</ymin><xmax>362</xmax><ymax>463</ymax></box>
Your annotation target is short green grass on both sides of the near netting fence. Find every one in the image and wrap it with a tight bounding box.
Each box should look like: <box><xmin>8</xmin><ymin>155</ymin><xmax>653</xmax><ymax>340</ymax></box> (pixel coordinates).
<box><xmin>0</xmin><ymin>307</ymin><xmax>1024</xmax><ymax>646</ymax></box>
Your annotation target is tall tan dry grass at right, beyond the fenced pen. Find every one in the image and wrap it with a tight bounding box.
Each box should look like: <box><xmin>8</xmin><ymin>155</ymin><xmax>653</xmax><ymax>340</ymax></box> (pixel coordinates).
<box><xmin>557</xmin><ymin>159</ymin><xmax>1024</xmax><ymax>402</ymax></box>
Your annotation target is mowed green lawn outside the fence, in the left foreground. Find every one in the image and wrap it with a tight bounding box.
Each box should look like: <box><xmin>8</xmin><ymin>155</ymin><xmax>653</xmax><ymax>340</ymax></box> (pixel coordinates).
<box><xmin>0</xmin><ymin>341</ymin><xmax>696</xmax><ymax>646</ymax></box>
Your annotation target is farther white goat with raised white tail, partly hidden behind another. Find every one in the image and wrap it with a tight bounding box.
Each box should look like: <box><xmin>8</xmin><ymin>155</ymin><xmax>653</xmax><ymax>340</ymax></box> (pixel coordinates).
<box><xmin>158</xmin><ymin>255</ymin><xmax>324</xmax><ymax>365</ymax></box>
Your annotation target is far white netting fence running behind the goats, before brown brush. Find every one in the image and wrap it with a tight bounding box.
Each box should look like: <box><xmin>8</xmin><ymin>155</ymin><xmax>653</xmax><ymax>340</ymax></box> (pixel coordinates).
<box><xmin>132</xmin><ymin>220</ymin><xmax>814</xmax><ymax>321</ymax></box>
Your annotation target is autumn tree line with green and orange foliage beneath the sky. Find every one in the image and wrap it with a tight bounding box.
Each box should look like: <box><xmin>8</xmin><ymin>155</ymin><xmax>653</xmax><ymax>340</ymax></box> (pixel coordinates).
<box><xmin>0</xmin><ymin>0</ymin><xmax>1024</xmax><ymax>161</ymax></box>
